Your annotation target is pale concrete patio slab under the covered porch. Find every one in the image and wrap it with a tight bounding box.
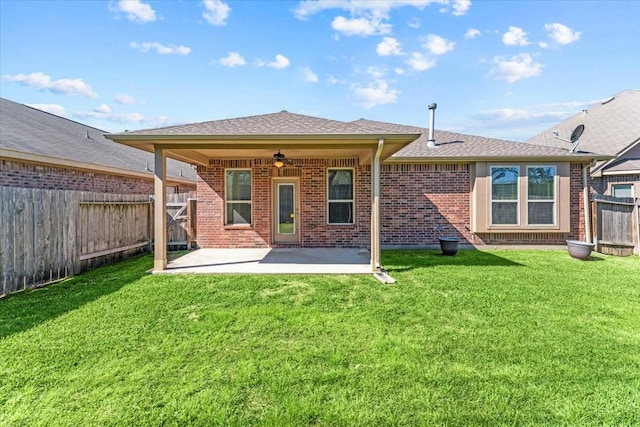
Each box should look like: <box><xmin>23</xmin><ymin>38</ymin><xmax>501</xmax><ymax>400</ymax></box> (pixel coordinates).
<box><xmin>158</xmin><ymin>248</ymin><xmax>372</xmax><ymax>274</ymax></box>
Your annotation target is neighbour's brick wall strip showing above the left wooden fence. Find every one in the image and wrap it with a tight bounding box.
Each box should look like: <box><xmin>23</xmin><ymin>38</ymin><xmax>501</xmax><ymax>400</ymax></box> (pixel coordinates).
<box><xmin>0</xmin><ymin>160</ymin><xmax>195</xmax><ymax>194</ymax></box>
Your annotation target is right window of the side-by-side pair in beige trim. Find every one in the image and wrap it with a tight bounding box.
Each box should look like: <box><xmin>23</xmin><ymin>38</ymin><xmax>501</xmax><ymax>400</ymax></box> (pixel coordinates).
<box><xmin>527</xmin><ymin>166</ymin><xmax>556</xmax><ymax>225</ymax></box>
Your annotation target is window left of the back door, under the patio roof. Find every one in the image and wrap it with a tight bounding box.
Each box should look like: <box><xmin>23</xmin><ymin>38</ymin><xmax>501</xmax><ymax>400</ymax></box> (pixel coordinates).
<box><xmin>225</xmin><ymin>169</ymin><xmax>251</xmax><ymax>225</ymax></box>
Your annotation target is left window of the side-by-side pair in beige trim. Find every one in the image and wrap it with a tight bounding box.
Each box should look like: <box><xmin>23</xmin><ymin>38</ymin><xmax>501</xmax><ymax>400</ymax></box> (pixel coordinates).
<box><xmin>491</xmin><ymin>166</ymin><xmax>520</xmax><ymax>225</ymax></box>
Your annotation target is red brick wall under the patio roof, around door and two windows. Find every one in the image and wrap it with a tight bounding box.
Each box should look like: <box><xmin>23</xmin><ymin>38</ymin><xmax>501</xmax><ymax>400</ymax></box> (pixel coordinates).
<box><xmin>197</xmin><ymin>159</ymin><xmax>371</xmax><ymax>248</ymax></box>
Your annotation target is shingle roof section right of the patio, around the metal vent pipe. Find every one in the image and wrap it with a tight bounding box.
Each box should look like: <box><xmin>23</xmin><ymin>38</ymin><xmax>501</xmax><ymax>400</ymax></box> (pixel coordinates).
<box><xmin>352</xmin><ymin>119</ymin><xmax>608</xmax><ymax>162</ymax></box>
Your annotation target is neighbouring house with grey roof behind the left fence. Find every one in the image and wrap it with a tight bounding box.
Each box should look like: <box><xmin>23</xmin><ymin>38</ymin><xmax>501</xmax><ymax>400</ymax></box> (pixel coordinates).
<box><xmin>0</xmin><ymin>98</ymin><xmax>196</xmax><ymax>194</ymax></box>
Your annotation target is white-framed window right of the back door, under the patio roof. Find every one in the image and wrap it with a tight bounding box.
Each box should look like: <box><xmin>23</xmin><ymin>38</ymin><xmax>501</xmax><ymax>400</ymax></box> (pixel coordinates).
<box><xmin>327</xmin><ymin>169</ymin><xmax>354</xmax><ymax>224</ymax></box>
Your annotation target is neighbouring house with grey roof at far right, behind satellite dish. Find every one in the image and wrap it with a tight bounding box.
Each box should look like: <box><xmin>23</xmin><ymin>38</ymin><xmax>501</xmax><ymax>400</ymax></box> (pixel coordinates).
<box><xmin>527</xmin><ymin>90</ymin><xmax>640</xmax><ymax>198</ymax></box>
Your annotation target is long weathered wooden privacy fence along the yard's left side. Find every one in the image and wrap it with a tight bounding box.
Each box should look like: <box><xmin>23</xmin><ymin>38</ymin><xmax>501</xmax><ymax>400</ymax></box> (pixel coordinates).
<box><xmin>0</xmin><ymin>187</ymin><xmax>195</xmax><ymax>295</ymax></box>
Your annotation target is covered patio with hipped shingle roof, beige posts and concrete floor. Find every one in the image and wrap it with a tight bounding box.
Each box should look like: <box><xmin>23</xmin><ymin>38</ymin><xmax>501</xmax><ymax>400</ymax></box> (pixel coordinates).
<box><xmin>106</xmin><ymin>111</ymin><xmax>420</xmax><ymax>283</ymax></box>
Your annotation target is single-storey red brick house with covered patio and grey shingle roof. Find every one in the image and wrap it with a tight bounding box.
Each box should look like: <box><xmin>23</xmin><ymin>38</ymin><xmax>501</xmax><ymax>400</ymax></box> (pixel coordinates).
<box><xmin>106</xmin><ymin>108</ymin><xmax>610</xmax><ymax>272</ymax></box>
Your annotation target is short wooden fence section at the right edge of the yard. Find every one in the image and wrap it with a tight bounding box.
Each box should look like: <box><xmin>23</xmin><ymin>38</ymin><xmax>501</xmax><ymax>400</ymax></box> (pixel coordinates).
<box><xmin>592</xmin><ymin>195</ymin><xmax>640</xmax><ymax>256</ymax></box>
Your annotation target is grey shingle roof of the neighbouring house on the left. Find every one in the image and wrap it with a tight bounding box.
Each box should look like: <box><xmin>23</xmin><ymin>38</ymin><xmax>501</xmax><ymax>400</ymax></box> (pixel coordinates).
<box><xmin>0</xmin><ymin>98</ymin><xmax>196</xmax><ymax>185</ymax></box>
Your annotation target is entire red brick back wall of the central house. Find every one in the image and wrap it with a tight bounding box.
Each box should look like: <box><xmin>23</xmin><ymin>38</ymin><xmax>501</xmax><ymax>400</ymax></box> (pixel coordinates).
<box><xmin>197</xmin><ymin>159</ymin><xmax>585</xmax><ymax>248</ymax></box>
